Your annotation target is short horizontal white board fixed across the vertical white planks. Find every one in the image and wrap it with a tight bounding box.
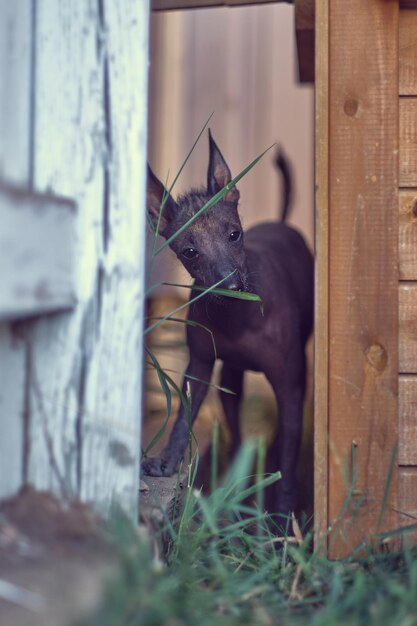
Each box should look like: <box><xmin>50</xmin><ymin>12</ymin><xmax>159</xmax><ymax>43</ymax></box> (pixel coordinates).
<box><xmin>0</xmin><ymin>180</ymin><xmax>76</xmax><ymax>319</ymax></box>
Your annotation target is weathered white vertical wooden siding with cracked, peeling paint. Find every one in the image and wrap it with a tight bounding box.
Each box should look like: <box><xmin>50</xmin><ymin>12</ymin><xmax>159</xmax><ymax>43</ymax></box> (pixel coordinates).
<box><xmin>0</xmin><ymin>0</ymin><xmax>149</xmax><ymax>513</ymax></box>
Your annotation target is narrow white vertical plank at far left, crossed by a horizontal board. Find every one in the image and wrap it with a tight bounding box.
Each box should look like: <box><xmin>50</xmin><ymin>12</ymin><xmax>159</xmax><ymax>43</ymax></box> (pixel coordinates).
<box><xmin>0</xmin><ymin>2</ymin><xmax>33</xmax><ymax>498</ymax></box>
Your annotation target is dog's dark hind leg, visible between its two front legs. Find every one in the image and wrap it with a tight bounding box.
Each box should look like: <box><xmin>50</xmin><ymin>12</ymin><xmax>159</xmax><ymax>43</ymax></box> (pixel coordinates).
<box><xmin>220</xmin><ymin>364</ymin><xmax>244</xmax><ymax>458</ymax></box>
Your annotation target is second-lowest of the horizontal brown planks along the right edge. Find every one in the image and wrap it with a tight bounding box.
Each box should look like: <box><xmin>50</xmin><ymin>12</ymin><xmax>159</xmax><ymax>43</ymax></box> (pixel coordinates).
<box><xmin>398</xmin><ymin>375</ymin><xmax>417</xmax><ymax>465</ymax></box>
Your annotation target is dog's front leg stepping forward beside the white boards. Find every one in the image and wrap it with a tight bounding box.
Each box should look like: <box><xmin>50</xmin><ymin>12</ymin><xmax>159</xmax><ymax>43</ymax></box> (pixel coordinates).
<box><xmin>142</xmin><ymin>357</ymin><xmax>214</xmax><ymax>476</ymax></box>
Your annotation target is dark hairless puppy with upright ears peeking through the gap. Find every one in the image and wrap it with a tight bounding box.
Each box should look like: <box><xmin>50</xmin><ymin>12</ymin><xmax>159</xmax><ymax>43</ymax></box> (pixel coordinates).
<box><xmin>142</xmin><ymin>131</ymin><xmax>313</xmax><ymax>516</ymax></box>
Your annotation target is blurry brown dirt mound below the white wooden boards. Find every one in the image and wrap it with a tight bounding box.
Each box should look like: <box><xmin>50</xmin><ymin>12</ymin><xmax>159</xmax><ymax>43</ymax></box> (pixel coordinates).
<box><xmin>0</xmin><ymin>487</ymin><xmax>117</xmax><ymax>626</ymax></box>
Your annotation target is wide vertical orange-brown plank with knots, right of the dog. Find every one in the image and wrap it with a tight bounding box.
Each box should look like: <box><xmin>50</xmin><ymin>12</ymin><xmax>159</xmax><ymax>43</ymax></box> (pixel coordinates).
<box><xmin>329</xmin><ymin>0</ymin><xmax>399</xmax><ymax>557</ymax></box>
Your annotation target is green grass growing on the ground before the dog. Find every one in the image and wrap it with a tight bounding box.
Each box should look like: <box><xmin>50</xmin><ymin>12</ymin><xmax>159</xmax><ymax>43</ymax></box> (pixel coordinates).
<box><xmin>84</xmin><ymin>442</ymin><xmax>417</xmax><ymax>626</ymax></box>
